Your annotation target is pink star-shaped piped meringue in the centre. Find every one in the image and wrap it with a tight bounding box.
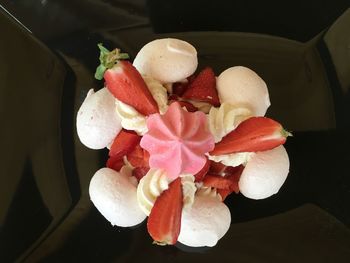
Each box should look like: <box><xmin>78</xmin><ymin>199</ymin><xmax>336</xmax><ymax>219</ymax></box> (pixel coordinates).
<box><xmin>140</xmin><ymin>102</ymin><xmax>214</xmax><ymax>179</ymax></box>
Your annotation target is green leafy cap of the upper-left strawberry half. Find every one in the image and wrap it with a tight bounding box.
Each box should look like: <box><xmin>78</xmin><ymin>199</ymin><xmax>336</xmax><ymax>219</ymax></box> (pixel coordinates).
<box><xmin>95</xmin><ymin>43</ymin><xmax>129</xmax><ymax>80</ymax></box>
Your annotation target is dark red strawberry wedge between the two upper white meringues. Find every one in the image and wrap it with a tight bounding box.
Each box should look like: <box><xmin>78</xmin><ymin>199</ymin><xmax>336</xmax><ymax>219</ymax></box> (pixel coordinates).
<box><xmin>182</xmin><ymin>67</ymin><xmax>220</xmax><ymax>107</ymax></box>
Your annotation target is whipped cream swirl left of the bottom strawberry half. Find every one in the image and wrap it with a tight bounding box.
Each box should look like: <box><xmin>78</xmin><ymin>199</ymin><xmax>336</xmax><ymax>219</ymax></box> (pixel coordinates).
<box><xmin>137</xmin><ymin>169</ymin><xmax>169</xmax><ymax>216</ymax></box>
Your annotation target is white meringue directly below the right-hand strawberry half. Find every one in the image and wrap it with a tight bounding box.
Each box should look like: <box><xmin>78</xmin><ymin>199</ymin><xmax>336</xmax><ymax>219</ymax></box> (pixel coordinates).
<box><xmin>238</xmin><ymin>145</ymin><xmax>289</xmax><ymax>199</ymax></box>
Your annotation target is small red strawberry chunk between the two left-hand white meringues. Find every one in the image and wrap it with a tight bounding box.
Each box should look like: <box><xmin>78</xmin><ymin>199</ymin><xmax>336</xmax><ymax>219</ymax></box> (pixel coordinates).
<box><xmin>109</xmin><ymin>129</ymin><xmax>141</xmax><ymax>159</ymax></box>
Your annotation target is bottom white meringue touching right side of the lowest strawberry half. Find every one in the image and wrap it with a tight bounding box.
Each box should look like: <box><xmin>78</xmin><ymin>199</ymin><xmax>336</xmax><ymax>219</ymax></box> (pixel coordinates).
<box><xmin>178</xmin><ymin>195</ymin><xmax>231</xmax><ymax>247</ymax></box>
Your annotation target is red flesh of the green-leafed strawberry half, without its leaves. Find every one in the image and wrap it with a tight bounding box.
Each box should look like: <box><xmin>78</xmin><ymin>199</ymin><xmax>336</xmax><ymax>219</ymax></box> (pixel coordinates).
<box><xmin>104</xmin><ymin>60</ymin><xmax>158</xmax><ymax>116</ymax></box>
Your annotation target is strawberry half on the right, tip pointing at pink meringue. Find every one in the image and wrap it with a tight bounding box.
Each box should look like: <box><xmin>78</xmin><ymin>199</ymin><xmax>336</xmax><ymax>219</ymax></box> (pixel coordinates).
<box><xmin>210</xmin><ymin>117</ymin><xmax>292</xmax><ymax>155</ymax></box>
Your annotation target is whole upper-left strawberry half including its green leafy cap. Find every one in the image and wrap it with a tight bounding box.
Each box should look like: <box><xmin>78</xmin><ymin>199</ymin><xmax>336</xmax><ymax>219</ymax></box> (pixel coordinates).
<box><xmin>95</xmin><ymin>44</ymin><xmax>158</xmax><ymax>116</ymax></box>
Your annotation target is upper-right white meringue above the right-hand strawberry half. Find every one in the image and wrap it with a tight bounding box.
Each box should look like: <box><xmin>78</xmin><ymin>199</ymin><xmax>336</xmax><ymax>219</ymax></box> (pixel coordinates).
<box><xmin>216</xmin><ymin>66</ymin><xmax>271</xmax><ymax>116</ymax></box>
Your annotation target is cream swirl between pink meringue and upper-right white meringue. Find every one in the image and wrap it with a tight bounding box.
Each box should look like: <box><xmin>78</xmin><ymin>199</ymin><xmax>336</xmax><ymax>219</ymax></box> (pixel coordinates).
<box><xmin>207</xmin><ymin>103</ymin><xmax>252</xmax><ymax>143</ymax></box>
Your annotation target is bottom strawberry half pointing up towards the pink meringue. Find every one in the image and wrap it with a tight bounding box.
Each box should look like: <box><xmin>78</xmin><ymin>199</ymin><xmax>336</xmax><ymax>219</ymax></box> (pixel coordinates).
<box><xmin>147</xmin><ymin>177</ymin><xmax>183</xmax><ymax>245</ymax></box>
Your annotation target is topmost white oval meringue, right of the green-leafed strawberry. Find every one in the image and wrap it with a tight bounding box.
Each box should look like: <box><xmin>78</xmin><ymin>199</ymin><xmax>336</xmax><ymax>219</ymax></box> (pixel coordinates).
<box><xmin>133</xmin><ymin>38</ymin><xmax>198</xmax><ymax>83</ymax></box>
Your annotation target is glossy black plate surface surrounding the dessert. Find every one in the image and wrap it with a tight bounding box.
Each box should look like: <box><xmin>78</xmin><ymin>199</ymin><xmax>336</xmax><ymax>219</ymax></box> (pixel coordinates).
<box><xmin>0</xmin><ymin>0</ymin><xmax>350</xmax><ymax>262</ymax></box>
